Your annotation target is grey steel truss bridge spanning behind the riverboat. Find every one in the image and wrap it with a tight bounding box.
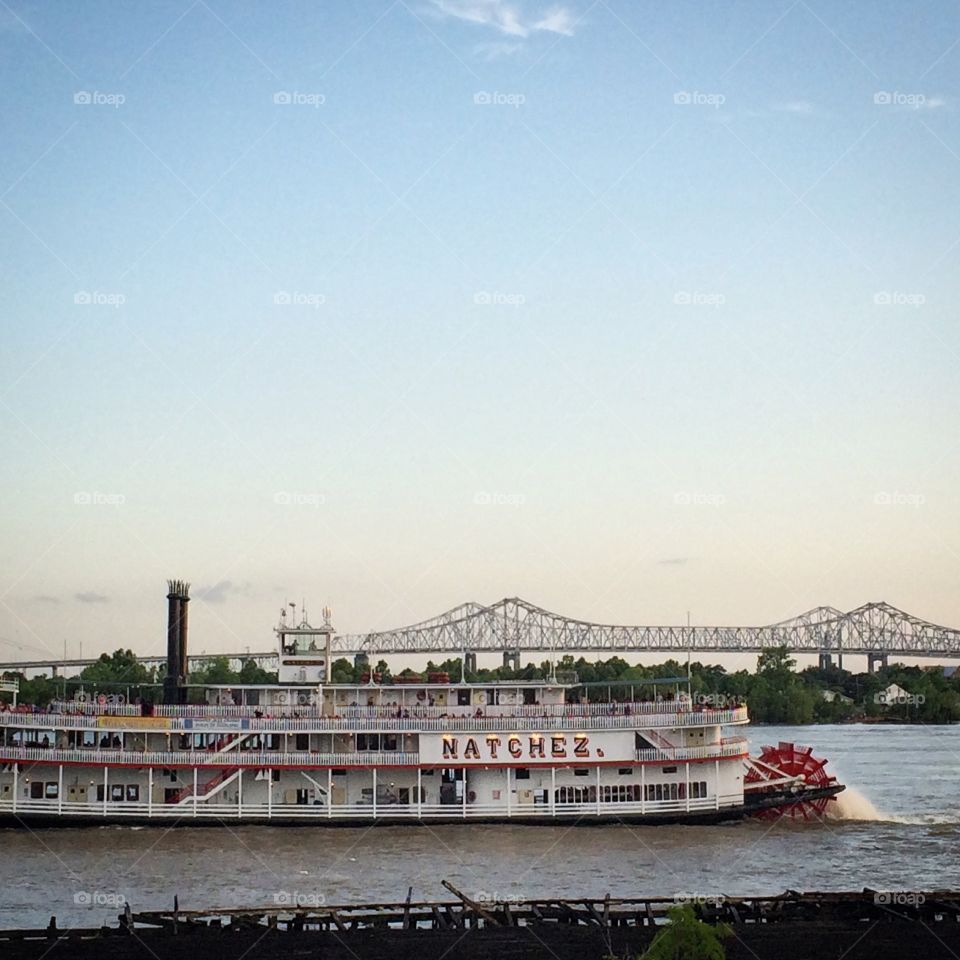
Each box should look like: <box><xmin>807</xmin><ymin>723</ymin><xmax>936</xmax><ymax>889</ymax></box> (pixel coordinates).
<box><xmin>0</xmin><ymin>597</ymin><xmax>960</xmax><ymax>674</ymax></box>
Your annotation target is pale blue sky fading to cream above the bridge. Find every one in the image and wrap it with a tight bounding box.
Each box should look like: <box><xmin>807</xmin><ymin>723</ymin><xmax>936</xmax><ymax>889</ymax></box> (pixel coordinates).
<box><xmin>0</xmin><ymin>0</ymin><xmax>960</xmax><ymax>659</ymax></box>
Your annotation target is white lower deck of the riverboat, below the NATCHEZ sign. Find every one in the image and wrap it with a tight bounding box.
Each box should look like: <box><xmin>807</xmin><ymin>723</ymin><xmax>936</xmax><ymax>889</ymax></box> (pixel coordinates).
<box><xmin>0</xmin><ymin>760</ymin><xmax>744</xmax><ymax>823</ymax></box>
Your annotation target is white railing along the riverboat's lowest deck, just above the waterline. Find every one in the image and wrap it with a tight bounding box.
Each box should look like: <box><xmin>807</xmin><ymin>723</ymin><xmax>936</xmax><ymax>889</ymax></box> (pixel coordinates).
<box><xmin>0</xmin><ymin>794</ymin><xmax>743</xmax><ymax>821</ymax></box>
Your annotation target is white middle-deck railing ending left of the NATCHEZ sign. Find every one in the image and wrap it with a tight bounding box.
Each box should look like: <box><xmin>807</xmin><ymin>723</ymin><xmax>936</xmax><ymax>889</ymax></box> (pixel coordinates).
<box><xmin>0</xmin><ymin>746</ymin><xmax>420</xmax><ymax>767</ymax></box>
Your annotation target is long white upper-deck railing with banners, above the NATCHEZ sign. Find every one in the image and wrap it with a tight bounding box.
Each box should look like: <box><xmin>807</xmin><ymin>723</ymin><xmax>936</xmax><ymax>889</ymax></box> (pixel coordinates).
<box><xmin>0</xmin><ymin>707</ymin><xmax>749</xmax><ymax>733</ymax></box>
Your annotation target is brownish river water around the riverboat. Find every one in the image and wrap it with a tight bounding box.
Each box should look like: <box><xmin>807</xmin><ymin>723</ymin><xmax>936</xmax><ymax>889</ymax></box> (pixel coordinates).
<box><xmin>0</xmin><ymin>725</ymin><xmax>960</xmax><ymax>927</ymax></box>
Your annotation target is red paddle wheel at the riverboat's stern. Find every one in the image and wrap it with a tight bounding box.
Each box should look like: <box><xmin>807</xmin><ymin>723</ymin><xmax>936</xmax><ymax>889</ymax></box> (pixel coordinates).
<box><xmin>743</xmin><ymin>741</ymin><xmax>843</xmax><ymax>820</ymax></box>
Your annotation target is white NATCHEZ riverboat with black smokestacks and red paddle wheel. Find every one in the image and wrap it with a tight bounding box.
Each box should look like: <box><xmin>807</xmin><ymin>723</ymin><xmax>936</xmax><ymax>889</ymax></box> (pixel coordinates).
<box><xmin>0</xmin><ymin>581</ymin><xmax>843</xmax><ymax>825</ymax></box>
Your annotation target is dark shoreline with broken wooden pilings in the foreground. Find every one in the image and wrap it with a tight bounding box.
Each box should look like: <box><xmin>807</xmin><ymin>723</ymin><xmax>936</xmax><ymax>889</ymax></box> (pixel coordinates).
<box><xmin>0</xmin><ymin>888</ymin><xmax>960</xmax><ymax>960</ymax></box>
